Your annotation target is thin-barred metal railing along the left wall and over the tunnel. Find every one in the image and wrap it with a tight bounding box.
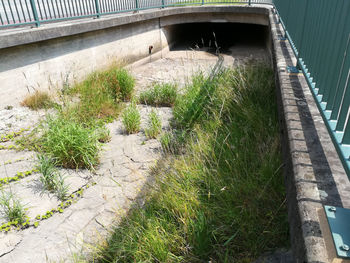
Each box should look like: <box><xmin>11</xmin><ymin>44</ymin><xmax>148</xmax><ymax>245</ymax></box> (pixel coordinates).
<box><xmin>0</xmin><ymin>0</ymin><xmax>272</xmax><ymax>29</ymax></box>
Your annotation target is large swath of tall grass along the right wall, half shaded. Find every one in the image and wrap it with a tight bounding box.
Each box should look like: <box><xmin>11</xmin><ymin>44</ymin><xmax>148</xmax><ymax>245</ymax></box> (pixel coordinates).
<box><xmin>97</xmin><ymin>65</ymin><xmax>288</xmax><ymax>262</ymax></box>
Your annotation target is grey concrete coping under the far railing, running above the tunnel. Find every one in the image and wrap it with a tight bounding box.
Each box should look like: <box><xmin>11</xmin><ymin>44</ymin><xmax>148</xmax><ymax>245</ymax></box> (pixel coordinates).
<box><xmin>0</xmin><ymin>6</ymin><xmax>268</xmax><ymax>49</ymax></box>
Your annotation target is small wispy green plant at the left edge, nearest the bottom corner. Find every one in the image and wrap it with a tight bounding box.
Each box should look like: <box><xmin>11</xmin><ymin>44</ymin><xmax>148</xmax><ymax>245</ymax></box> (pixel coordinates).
<box><xmin>0</xmin><ymin>191</ymin><xmax>26</xmax><ymax>224</ymax></box>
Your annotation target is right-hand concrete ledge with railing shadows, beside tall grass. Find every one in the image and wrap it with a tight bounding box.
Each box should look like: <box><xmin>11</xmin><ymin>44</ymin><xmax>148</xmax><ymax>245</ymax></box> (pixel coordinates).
<box><xmin>269</xmin><ymin>8</ymin><xmax>350</xmax><ymax>262</ymax></box>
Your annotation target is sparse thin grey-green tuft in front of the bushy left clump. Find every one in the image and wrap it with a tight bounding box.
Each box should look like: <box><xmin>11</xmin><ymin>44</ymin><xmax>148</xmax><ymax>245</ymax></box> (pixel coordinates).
<box><xmin>37</xmin><ymin>155</ymin><xmax>68</xmax><ymax>200</ymax></box>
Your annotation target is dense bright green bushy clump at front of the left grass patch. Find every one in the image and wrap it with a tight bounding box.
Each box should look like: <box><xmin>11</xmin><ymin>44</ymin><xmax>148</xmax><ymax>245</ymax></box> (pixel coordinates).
<box><xmin>41</xmin><ymin>116</ymin><xmax>100</xmax><ymax>169</ymax></box>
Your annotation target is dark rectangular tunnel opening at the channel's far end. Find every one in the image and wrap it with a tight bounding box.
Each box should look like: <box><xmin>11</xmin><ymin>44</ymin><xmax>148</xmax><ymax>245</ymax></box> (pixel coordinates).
<box><xmin>165</xmin><ymin>23</ymin><xmax>271</xmax><ymax>61</ymax></box>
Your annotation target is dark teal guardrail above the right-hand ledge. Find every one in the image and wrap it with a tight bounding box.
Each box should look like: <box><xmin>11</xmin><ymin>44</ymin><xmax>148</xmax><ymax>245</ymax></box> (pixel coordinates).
<box><xmin>274</xmin><ymin>0</ymin><xmax>350</xmax><ymax>177</ymax></box>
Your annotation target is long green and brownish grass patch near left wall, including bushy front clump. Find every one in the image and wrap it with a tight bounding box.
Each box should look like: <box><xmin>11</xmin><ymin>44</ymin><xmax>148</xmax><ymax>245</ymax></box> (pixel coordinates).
<box><xmin>16</xmin><ymin>66</ymin><xmax>135</xmax><ymax>169</ymax></box>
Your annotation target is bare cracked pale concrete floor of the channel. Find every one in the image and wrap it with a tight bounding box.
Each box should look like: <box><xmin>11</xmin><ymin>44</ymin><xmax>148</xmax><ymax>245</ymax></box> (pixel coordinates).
<box><xmin>0</xmin><ymin>48</ymin><xmax>268</xmax><ymax>263</ymax></box>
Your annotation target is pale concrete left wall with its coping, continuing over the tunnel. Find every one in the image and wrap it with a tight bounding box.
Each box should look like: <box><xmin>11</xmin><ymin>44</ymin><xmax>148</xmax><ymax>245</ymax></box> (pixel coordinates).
<box><xmin>0</xmin><ymin>6</ymin><xmax>268</xmax><ymax>107</ymax></box>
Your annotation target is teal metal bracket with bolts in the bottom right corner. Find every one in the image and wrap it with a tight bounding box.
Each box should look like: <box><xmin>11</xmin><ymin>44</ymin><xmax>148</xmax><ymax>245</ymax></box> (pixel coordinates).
<box><xmin>324</xmin><ymin>205</ymin><xmax>350</xmax><ymax>259</ymax></box>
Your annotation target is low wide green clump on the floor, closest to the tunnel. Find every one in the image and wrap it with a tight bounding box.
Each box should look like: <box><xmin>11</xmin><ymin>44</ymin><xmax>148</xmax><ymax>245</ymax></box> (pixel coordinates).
<box><xmin>139</xmin><ymin>83</ymin><xmax>177</xmax><ymax>107</ymax></box>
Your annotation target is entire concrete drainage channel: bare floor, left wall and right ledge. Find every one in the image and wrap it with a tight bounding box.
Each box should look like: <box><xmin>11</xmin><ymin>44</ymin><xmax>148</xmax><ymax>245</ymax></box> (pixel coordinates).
<box><xmin>0</xmin><ymin>6</ymin><xmax>350</xmax><ymax>262</ymax></box>
